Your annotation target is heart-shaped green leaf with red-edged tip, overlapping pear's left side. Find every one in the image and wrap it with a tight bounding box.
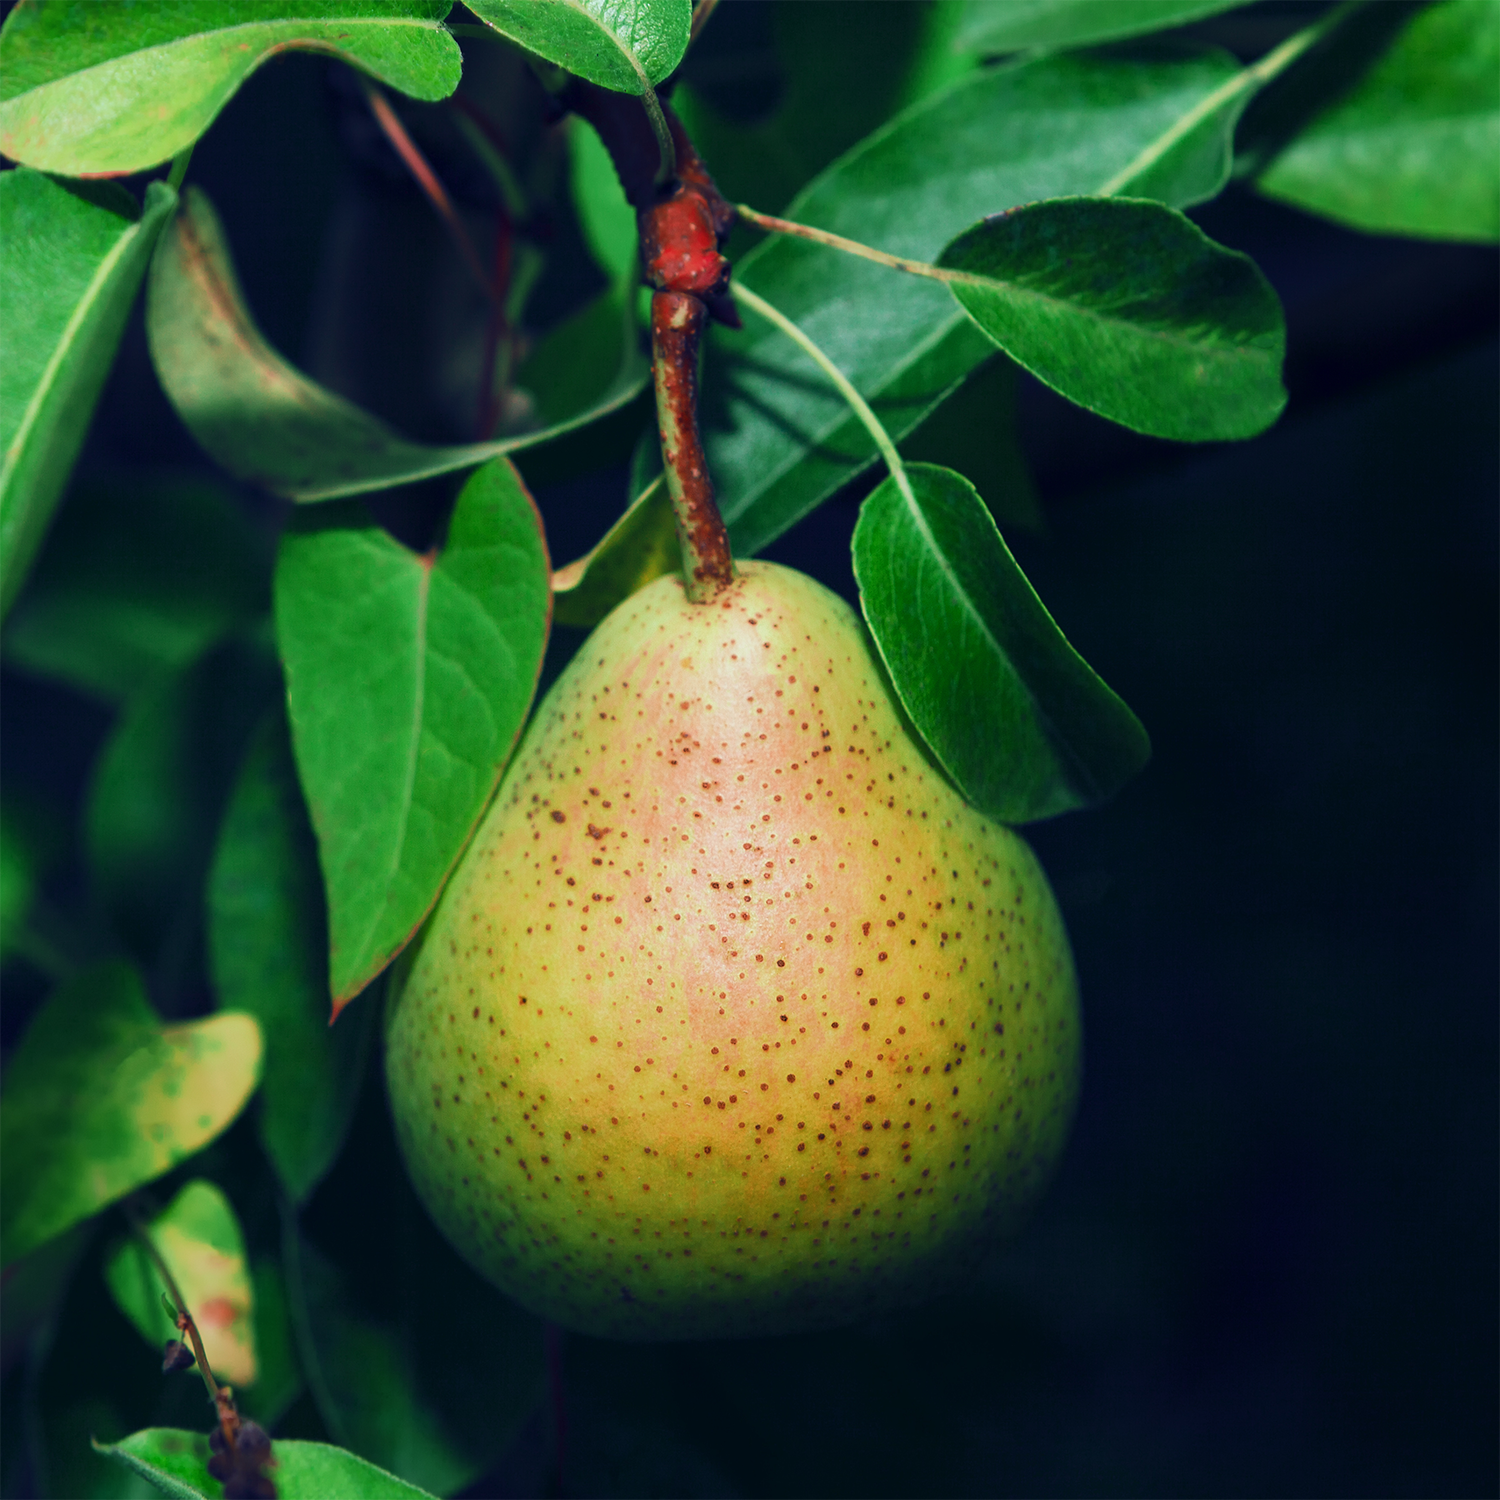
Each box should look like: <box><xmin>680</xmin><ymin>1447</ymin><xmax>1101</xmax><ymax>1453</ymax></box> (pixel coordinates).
<box><xmin>276</xmin><ymin>459</ymin><xmax>551</xmax><ymax>1008</ymax></box>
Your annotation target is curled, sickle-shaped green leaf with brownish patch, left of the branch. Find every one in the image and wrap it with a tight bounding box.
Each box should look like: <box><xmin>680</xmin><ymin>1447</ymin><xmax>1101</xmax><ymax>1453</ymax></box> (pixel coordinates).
<box><xmin>146</xmin><ymin>189</ymin><xmax>650</xmax><ymax>501</ymax></box>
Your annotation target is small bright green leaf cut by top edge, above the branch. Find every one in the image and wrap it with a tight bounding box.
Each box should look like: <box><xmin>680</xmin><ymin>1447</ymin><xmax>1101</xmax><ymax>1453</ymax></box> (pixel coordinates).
<box><xmin>468</xmin><ymin>0</ymin><xmax>693</xmax><ymax>93</ymax></box>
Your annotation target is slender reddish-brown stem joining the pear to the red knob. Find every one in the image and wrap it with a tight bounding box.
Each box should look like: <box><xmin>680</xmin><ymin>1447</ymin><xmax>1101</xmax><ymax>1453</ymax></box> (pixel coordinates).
<box><xmin>651</xmin><ymin>291</ymin><xmax>735</xmax><ymax>605</ymax></box>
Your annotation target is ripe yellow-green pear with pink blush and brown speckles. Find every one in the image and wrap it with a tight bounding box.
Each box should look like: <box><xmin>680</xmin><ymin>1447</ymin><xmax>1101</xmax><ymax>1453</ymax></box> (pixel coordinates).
<box><xmin>387</xmin><ymin>563</ymin><xmax>1080</xmax><ymax>1340</ymax></box>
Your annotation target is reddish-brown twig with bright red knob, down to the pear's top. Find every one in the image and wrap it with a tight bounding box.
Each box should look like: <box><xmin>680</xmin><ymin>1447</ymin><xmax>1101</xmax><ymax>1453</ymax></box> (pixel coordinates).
<box><xmin>564</xmin><ymin>81</ymin><xmax>740</xmax><ymax>603</ymax></box>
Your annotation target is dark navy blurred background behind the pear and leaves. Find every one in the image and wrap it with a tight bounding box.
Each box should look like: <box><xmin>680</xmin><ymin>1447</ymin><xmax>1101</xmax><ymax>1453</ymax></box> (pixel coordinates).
<box><xmin>0</xmin><ymin>0</ymin><xmax>1500</xmax><ymax>1500</ymax></box>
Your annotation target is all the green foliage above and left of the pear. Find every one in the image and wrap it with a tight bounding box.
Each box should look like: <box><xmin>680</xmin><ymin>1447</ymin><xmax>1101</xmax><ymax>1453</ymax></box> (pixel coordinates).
<box><xmin>0</xmin><ymin>0</ymin><xmax>1500</xmax><ymax>1500</ymax></box>
